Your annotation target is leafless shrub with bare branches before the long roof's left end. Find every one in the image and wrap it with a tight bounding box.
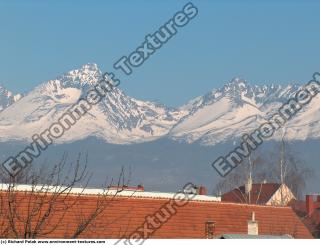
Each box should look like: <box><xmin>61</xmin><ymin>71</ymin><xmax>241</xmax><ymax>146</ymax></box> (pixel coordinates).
<box><xmin>0</xmin><ymin>154</ymin><xmax>130</xmax><ymax>239</ymax></box>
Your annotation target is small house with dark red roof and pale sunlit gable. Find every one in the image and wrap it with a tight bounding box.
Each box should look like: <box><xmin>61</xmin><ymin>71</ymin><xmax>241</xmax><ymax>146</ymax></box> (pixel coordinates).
<box><xmin>221</xmin><ymin>183</ymin><xmax>295</xmax><ymax>206</ymax></box>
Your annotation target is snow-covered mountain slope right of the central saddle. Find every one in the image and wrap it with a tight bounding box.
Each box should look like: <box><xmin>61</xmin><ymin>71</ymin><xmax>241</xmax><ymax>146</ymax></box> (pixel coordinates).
<box><xmin>170</xmin><ymin>78</ymin><xmax>299</xmax><ymax>145</ymax></box>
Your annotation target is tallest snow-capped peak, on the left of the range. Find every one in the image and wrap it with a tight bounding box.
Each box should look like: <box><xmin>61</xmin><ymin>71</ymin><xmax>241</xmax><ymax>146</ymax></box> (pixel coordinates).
<box><xmin>0</xmin><ymin>64</ymin><xmax>185</xmax><ymax>143</ymax></box>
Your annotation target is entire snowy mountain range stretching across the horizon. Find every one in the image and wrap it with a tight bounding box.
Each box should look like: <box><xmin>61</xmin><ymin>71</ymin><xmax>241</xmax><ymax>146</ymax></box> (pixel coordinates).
<box><xmin>0</xmin><ymin>64</ymin><xmax>320</xmax><ymax>145</ymax></box>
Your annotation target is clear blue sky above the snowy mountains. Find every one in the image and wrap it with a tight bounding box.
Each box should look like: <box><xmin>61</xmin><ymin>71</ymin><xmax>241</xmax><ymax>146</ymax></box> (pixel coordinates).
<box><xmin>0</xmin><ymin>0</ymin><xmax>320</xmax><ymax>106</ymax></box>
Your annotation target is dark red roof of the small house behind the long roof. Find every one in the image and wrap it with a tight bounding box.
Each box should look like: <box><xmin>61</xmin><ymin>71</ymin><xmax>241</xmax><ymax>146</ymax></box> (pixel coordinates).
<box><xmin>221</xmin><ymin>183</ymin><xmax>281</xmax><ymax>204</ymax></box>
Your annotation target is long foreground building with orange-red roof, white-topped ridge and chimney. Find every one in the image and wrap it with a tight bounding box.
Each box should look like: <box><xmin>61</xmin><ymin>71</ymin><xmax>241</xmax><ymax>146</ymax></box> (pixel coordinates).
<box><xmin>0</xmin><ymin>185</ymin><xmax>313</xmax><ymax>238</ymax></box>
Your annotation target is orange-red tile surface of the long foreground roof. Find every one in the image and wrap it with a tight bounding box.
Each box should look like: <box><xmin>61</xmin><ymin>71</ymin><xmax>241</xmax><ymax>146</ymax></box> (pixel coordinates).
<box><xmin>0</xmin><ymin>189</ymin><xmax>312</xmax><ymax>239</ymax></box>
